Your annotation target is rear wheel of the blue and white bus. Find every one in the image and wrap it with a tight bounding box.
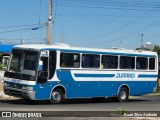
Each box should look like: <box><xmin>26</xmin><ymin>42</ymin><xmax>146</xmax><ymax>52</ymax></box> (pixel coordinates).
<box><xmin>117</xmin><ymin>87</ymin><xmax>128</xmax><ymax>102</ymax></box>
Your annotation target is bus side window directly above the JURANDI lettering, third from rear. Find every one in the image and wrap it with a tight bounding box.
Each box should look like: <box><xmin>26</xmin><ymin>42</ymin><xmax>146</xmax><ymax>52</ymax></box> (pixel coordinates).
<box><xmin>120</xmin><ymin>56</ymin><xmax>135</xmax><ymax>69</ymax></box>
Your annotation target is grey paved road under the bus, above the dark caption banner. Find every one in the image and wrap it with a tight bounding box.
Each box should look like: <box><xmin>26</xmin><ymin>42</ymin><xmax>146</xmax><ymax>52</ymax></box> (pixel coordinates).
<box><xmin>0</xmin><ymin>95</ymin><xmax>160</xmax><ymax>111</ymax></box>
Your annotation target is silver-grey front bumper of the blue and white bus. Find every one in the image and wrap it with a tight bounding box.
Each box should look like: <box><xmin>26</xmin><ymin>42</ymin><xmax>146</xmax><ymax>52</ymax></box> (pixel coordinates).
<box><xmin>4</xmin><ymin>86</ymin><xmax>35</xmax><ymax>100</ymax></box>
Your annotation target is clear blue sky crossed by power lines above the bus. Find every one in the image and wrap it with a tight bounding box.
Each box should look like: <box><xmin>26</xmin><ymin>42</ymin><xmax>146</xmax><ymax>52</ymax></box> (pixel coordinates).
<box><xmin>0</xmin><ymin>0</ymin><xmax>160</xmax><ymax>49</ymax></box>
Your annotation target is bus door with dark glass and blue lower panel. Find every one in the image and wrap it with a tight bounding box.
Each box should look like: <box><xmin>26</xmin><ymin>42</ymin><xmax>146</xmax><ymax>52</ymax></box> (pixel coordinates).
<box><xmin>35</xmin><ymin>50</ymin><xmax>49</xmax><ymax>99</ymax></box>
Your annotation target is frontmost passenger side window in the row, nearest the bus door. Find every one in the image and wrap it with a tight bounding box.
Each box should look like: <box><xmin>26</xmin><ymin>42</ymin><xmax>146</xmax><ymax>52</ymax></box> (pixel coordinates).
<box><xmin>60</xmin><ymin>53</ymin><xmax>80</xmax><ymax>68</ymax></box>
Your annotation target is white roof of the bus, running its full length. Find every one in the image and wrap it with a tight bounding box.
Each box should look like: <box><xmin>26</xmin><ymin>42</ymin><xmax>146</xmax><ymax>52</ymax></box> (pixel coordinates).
<box><xmin>13</xmin><ymin>43</ymin><xmax>157</xmax><ymax>56</ymax></box>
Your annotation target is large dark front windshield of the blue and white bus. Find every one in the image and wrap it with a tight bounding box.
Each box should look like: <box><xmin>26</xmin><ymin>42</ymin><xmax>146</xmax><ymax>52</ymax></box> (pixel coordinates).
<box><xmin>9</xmin><ymin>51</ymin><xmax>38</xmax><ymax>76</ymax></box>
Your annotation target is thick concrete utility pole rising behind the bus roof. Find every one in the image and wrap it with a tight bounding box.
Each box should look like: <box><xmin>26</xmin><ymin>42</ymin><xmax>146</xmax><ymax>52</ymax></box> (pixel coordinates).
<box><xmin>47</xmin><ymin>0</ymin><xmax>53</xmax><ymax>45</ymax></box>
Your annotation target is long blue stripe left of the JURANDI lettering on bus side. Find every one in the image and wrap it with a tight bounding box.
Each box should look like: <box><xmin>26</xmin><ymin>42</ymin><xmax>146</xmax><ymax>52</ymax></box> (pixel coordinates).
<box><xmin>74</xmin><ymin>74</ymin><xmax>115</xmax><ymax>77</ymax></box>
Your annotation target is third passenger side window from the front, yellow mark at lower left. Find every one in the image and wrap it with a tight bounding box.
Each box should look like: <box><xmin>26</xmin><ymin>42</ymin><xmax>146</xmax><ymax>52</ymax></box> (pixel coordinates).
<box><xmin>102</xmin><ymin>55</ymin><xmax>118</xmax><ymax>69</ymax></box>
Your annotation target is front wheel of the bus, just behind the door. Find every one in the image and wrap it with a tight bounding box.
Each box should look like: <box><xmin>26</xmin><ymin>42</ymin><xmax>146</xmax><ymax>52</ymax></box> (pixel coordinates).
<box><xmin>50</xmin><ymin>89</ymin><xmax>64</xmax><ymax>104</ymax></box>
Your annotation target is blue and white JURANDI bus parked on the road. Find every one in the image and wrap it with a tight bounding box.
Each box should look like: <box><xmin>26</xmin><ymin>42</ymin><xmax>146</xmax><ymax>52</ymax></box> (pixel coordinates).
<box><xmin>4</xmin><ymin>44</ymin><xmax>158</xmax><ymax>104</ymax></box>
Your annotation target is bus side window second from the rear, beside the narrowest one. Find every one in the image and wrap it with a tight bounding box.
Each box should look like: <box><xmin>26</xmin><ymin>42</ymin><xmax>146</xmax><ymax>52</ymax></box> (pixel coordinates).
<box><xmin>136</xmin><ymin>57</ymin><xmax>148</xmax><ymax>70</ymax></box>
